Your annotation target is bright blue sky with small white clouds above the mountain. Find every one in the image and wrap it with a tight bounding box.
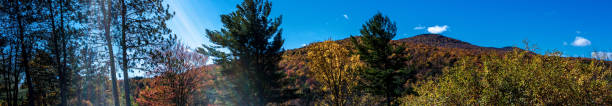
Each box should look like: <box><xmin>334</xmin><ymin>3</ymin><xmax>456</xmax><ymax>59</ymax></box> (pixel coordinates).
<box><xmin>167</xmin><ymin>0</ymin><xmax>612</xmax><ymax>57</ymax></box>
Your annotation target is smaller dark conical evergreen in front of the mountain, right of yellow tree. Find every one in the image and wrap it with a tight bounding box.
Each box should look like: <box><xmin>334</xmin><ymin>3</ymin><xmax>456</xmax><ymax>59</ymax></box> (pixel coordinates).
<box><xmin>351</xmin><ymin>13</ymin><xmax>412</xmax><ymax>105</ymax></box>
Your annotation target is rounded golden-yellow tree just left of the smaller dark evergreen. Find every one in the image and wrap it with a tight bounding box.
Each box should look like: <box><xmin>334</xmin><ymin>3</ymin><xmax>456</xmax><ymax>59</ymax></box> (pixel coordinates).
<box><xmin>307</xmin><ymin>41</ymin><xmax>363</xmax><ymax>105</ymax></box>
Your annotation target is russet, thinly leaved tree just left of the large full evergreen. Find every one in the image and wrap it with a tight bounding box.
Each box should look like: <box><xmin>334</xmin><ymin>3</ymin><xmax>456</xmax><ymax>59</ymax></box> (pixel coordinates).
<box><xmin>136</xmin><ymin>45</ymin><xmax>213</xmax><ymax>106</ymax></box>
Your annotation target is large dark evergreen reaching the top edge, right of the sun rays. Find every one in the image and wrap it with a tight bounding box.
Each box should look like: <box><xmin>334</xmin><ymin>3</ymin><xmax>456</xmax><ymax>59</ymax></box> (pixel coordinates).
<box><xmin>198</xmin><ymin>0</ymin><xmax>292</xmax><ymax>105</ymax></box>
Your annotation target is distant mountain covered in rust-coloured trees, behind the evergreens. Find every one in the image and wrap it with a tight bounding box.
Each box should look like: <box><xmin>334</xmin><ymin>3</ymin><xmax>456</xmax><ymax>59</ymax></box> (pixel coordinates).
<box><xmin>279</xmin><ymin>34</ymin><xmax>523</xmax><ymax>78</ymax></box>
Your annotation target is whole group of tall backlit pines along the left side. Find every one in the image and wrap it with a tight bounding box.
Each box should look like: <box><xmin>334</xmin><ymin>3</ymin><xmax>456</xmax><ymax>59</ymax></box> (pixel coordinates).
<box><xmin>0</xmin><ymin>0</ymin><xmax>176</xmax><ymax>106</ymax></box>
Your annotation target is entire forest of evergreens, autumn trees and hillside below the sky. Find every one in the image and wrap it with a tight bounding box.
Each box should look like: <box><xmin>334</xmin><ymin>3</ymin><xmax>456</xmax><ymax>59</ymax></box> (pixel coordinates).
<box><xmin>0</xmin><ymin>0</ymin><xmax>612</xmax><ymax>106</ymax></box>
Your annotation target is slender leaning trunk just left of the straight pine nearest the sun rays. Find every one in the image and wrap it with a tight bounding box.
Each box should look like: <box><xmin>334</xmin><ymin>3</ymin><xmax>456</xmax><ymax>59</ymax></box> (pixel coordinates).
<box><xmin>102</xmin><ymin>0</ymin><xmax>119</xmax><ymax>106</ymax></box>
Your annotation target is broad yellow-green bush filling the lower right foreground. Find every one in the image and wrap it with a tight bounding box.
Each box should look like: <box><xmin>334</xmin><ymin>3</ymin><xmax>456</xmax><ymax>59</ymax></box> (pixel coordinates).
<box><xmin>403</xmin><ymin>50</ymin><xmax>612</xmax><ymax>105</ymax></box>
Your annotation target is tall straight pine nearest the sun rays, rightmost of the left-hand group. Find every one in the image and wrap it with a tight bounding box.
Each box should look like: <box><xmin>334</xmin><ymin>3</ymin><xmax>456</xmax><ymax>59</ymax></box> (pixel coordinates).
<box><xmin>117</xmin><ymin>0</ymin><xmax>175</xmax><ymax>106</ymax></box>
